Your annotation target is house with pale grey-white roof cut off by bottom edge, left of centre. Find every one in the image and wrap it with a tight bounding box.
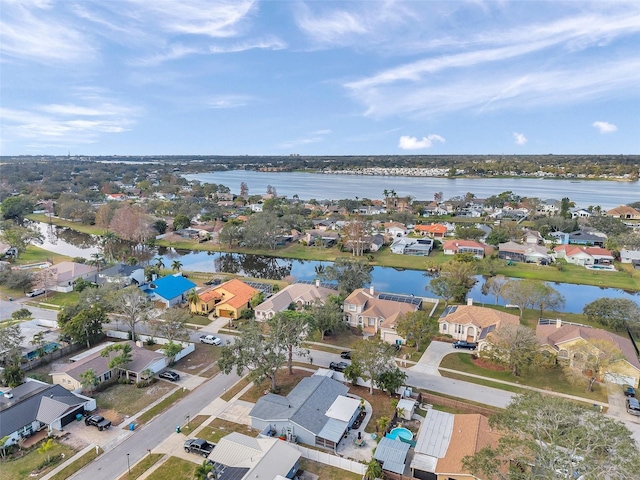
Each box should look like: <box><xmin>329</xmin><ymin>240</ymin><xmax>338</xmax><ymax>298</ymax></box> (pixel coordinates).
<box><xmin>209</xmin><ymin>432</ymin><xmax>302</xmax><ymax>480</ymax></box>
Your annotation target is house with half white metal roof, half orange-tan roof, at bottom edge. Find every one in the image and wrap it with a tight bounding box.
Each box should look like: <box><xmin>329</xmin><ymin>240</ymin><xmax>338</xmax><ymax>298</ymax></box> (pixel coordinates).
<box><xmin>410</xmin><ymin>409</ymin><xmax>501</xmax><ymax>480</ymax></box>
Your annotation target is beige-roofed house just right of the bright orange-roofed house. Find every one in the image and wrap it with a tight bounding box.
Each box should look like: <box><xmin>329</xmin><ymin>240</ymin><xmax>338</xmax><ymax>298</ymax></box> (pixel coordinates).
<box><xmin>254</xmin><ymin>281</ymin><xmax>338</xmax><ymax>321</ymax></box>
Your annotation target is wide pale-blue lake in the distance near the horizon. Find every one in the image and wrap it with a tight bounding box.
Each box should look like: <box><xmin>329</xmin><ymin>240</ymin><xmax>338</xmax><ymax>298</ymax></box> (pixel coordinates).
<box><xmin>184</xmin><ymin>170</ymin><xmax>640</xmax><ymax>209</ymax></box>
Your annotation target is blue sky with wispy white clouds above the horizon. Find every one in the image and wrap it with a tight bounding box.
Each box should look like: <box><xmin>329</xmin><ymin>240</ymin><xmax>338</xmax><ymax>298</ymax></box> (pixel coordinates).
<box><xmin>0</xmin><ymin>0</ymin><xmax>640</xmax><ymax>155</ymax></box>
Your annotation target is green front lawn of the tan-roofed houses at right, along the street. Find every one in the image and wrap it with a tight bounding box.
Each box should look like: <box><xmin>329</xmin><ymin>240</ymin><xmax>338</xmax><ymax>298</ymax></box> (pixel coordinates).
<box><xmin>440</xmin><ymin>353</ymin><xmax>607</xmax><ymax>402</ymax></box>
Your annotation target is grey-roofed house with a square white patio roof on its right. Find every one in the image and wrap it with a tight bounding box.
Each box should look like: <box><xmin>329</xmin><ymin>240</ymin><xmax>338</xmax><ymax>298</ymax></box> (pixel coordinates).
<box><xmin>249</xmin><ymin>375</ymin><xmax>360</xmax><ymax>449</ymax></box>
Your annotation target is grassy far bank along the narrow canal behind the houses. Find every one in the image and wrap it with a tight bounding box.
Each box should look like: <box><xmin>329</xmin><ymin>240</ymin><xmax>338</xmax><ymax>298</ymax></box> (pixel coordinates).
<box><xmin>21</xmin><ymin>214</ymin><xmax>640</xmax><ymax>291</ymax></box>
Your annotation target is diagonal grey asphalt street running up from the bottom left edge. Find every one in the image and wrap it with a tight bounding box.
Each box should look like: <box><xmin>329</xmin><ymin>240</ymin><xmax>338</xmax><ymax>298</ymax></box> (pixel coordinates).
<box><xmin>70</xmin><ymin>373</ymin><xmax>239</xmax><ymax>480</ymax></box>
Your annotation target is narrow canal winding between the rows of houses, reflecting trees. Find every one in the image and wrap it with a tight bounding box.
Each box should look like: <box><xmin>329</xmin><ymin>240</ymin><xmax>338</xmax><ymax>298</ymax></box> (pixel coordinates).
<box><xmin>28</xmin><ymin>223</ymin><xmax>640</xmax><ymax>313</ymax></box>
